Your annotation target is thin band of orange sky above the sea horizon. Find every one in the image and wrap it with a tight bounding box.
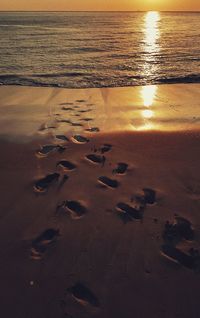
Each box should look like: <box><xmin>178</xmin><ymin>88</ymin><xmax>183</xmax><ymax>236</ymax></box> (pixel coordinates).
<box><xmin>0</xmin><ymin>0</ymin><xmax>200</xmax><ymax>11</ymax></box>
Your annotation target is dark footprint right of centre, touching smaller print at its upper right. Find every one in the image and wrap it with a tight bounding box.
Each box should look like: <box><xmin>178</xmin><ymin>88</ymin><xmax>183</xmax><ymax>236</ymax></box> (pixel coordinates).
<box><xmin>116</xmin><ymin>202</ymin><xmax>143</xmax><ymax>223</ymax></box>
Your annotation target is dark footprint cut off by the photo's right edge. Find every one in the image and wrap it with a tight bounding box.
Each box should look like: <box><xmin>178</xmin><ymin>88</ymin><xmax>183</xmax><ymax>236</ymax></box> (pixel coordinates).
<box><xmin>161</xmin><ymin>244</ymin><xmax>200</xmax><ymax>270</ymax></box>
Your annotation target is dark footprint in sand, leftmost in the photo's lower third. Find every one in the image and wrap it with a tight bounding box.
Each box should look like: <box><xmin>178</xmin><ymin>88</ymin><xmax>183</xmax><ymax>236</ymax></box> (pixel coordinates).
<box><xmin>31</xmin><ymin>229</ymin><xmax>59</xmax><ymax>260</ymax></box>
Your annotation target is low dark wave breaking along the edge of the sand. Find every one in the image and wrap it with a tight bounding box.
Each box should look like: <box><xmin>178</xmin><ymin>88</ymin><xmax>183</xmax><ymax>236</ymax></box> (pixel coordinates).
<box><xmin>0</xmin><ymin>72</ymin><xmax>200</xmax><ymax>88</ymax></box>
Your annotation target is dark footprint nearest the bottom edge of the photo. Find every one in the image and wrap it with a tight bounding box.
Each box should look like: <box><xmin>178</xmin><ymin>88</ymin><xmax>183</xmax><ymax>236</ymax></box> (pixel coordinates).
<box><xmin>67</xmin><ymin>283</ymin><xmax>100</xmax><ymax>307</ymax></box>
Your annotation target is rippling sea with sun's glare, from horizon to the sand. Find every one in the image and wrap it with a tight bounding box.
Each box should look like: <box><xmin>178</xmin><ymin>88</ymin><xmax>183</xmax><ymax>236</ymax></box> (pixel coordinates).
<box><xmin>0</xmin><ymin>12</ymin><xmax>200</xmax><ymax>88</ymax></box>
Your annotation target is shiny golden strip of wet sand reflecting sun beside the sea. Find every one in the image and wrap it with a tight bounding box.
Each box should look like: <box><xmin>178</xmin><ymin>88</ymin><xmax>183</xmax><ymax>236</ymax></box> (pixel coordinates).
<box><xmin>0</xmin><ymin>84</ymin><xmax>200</xmax><ymax>140</ymax></box>
